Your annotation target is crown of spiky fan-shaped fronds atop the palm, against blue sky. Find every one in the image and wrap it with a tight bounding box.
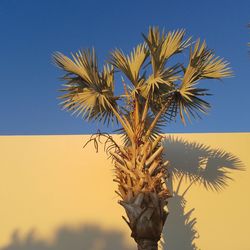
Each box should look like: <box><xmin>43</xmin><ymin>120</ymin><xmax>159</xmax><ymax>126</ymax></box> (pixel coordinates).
<box><xmin>54</xmin><ymin>27</ymin><xmax>231</xmax><ymax>137</ymax></box>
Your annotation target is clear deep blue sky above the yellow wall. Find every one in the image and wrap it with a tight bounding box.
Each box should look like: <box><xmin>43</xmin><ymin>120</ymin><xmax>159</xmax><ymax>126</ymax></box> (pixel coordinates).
<box><xmin>0</xmin><ymin>0</ymin><xmax>250</xmax><ymax>135</ymax></box>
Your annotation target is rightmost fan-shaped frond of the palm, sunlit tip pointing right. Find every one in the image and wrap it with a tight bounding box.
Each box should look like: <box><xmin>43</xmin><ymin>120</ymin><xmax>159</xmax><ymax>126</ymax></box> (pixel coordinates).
<box><xmin>175</xmin><ymin>40</ymin><xmax>232</xmax><ymax>124</ymax></box>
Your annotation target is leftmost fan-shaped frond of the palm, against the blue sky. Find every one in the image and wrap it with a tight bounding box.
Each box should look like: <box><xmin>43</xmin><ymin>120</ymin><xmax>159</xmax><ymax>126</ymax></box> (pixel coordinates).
<box><xmin>54</xmin><ymin>49</ymin><xmax>116</xmax><ymax>123</ymax></box>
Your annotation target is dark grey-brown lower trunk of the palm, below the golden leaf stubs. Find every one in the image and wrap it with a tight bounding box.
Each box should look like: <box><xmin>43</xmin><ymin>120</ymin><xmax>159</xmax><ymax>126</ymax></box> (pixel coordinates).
<box><xmin>120</xmin><ymin>192</ymin><xmax>168</xmax><ymax>250</ymax></box>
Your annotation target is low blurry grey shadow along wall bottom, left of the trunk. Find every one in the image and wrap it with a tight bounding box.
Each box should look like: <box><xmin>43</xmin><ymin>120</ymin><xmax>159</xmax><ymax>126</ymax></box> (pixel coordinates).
<box><xmin>1</xmin><ymin>225</ymin><xmax>134</xmax><ymax>250</ymax></box>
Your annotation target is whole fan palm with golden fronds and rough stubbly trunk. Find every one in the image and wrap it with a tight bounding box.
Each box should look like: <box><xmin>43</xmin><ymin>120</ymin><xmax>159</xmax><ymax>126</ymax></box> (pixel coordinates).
<box><xmin>53</xmin><ymin>27</ymin><xmax>231</xmax><ymax>250</ymax></box>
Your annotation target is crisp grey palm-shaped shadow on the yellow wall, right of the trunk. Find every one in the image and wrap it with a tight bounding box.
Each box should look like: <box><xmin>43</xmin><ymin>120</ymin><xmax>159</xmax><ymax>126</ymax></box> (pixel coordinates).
<box><xmin>161</xmin><ymin>136</ymin><xmax>244</xmax><ymax>250</ymax></box>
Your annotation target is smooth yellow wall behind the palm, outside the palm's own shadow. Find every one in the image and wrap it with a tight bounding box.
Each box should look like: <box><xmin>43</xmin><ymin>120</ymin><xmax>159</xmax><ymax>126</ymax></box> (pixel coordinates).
<box><xmin>0</xmin><ymin>133</ymin><xmax>250</xmax><ymax>250</ymax></box>
